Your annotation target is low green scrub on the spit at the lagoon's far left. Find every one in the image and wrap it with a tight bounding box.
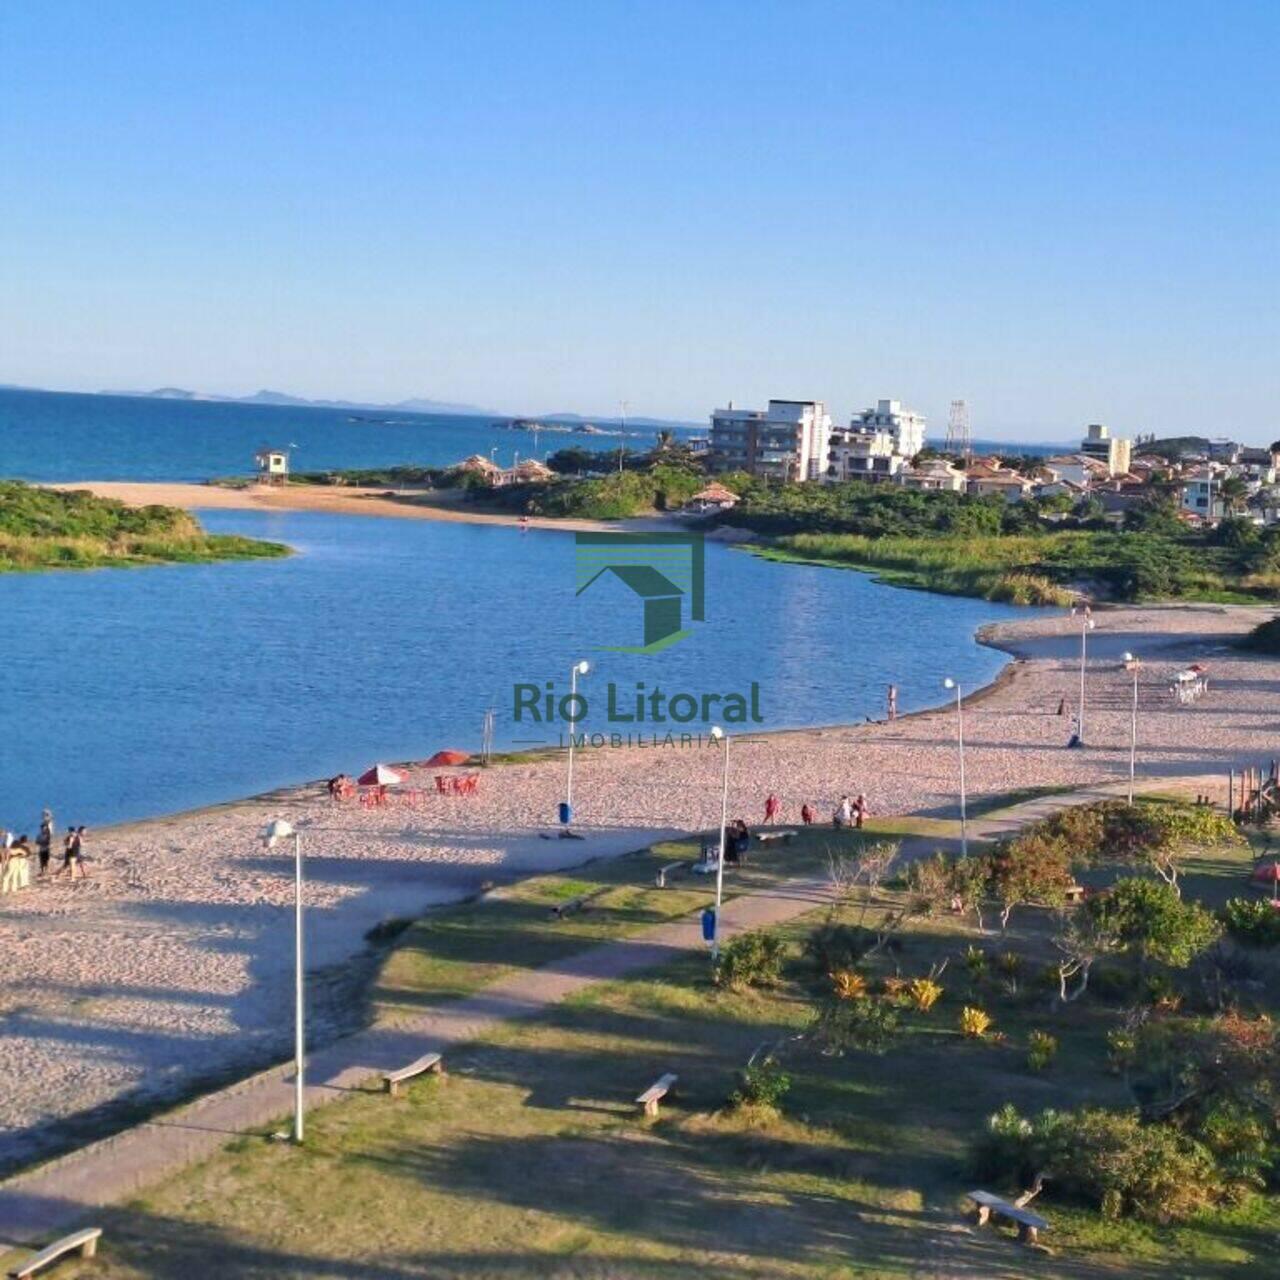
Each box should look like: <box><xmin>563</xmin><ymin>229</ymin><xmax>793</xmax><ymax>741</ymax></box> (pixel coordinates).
<box><xmin>0</xmin><ymin>480</ymin><xmax>289</xmax><ymax>572</ymax></box>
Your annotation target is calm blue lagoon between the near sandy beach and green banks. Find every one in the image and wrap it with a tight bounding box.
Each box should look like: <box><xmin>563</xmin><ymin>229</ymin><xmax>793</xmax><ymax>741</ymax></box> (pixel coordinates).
<box><xmin>0</xmin><ymin>511</ymin><xmax>1027</xmax><ymax>829</ymax></box>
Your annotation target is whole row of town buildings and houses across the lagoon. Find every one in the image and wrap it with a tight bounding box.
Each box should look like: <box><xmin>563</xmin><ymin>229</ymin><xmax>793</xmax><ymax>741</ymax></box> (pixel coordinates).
<box><xmin>707</xmin><ymin>399</ymin><xmax>1280</xmax><ymax>524</ymax></box>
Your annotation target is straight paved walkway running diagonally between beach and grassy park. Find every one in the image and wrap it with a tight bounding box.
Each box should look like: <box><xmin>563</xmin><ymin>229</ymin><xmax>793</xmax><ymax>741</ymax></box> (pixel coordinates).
<box><xmin>0</xmin><ymin>778</ymin><xmax>1221</xmax><ymax>1248</ymax></box>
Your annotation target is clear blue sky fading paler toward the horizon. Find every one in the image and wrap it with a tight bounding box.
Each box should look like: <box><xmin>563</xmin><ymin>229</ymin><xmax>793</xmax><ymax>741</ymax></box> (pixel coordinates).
<box><xmin>0</xmin><ymin>0</ymin><xmax>1280</xmax><ymax>439</ymax></box>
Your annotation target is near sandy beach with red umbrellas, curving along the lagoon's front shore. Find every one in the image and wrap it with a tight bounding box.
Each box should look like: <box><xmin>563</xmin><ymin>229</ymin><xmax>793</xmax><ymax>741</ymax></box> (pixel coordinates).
<box><xmin>0</xmin><ymin>604</ymin><xmax>1280</xmax><ymax>1167</ymax></box>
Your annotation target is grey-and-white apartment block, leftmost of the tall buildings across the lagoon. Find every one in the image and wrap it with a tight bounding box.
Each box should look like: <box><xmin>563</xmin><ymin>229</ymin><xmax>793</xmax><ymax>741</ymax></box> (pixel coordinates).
<box><xmin>708</xmin><ymin>399</ymin><xmax>831</xmax><ymax>481</ymax></box>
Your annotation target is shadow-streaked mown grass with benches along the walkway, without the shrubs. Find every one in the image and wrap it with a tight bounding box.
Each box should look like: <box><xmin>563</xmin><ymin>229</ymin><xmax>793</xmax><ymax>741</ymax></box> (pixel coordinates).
<box><xmin>12</xmin><ymin>803</ymin><xmax>1280</xmax><ymax>1280</ymax></box>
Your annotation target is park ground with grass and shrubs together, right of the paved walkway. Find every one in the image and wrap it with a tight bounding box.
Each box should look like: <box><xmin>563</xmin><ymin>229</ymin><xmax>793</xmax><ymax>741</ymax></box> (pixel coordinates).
<box><xmin>68</xmin><ymin>793</ymin><xmax>1277</xmax><ymax>1280</ymax></box>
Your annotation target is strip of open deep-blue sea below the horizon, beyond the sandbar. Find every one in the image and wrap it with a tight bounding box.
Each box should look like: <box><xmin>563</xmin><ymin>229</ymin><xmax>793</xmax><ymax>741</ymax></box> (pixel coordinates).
<box><xmin>0</xmin><ymin>390</ymin><xmax>654</xmax><ymax>483</ymax></box>
